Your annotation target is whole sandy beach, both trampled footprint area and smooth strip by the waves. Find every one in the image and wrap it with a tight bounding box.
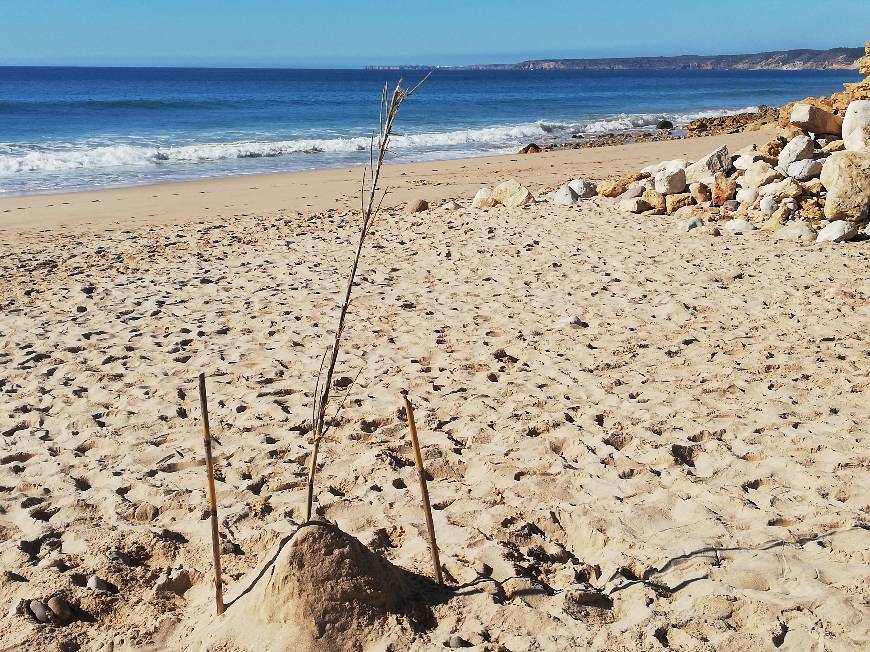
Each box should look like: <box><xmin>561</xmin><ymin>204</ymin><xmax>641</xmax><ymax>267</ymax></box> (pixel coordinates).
<box><xmin>0</xmin><ymin>133</ymin><xmax>870</xmax><ymax>652</ymax></box>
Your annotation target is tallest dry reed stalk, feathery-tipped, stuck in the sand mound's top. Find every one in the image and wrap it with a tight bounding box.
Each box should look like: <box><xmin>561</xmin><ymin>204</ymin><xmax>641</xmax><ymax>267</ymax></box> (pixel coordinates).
<box><xmin>305</xmin><ymin>75</ymin><xmax>429</xmax><ymax>522</ymax></box>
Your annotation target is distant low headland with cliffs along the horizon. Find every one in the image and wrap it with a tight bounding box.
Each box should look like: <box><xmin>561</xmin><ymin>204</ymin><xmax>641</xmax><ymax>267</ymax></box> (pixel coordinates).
<box><xmin>370</xmin><ymin>48</ymin><xmax>864</xmax><ymax>70</ymax></box>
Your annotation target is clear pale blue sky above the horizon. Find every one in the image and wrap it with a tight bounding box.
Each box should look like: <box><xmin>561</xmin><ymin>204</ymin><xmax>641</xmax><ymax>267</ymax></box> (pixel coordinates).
<box><xmin>0</xmin><ymin>0</ymin><xmax>870</xmax><ymax>67</ymax></box>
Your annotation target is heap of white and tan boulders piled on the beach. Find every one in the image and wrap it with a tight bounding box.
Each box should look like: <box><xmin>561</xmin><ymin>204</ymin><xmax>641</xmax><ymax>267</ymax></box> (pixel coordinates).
<box><xmin>599</xmin><ymin>99</ymin><xmax>870</xmax><ymax>242</ymax></box>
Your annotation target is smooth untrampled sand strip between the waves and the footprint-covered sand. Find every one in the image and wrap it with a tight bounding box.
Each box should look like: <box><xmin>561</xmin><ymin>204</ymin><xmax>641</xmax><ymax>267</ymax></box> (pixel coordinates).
<box><xmin>0</xmin><ymin>130</ymin><xmax>770</xmax><ymax>234</ymax></box>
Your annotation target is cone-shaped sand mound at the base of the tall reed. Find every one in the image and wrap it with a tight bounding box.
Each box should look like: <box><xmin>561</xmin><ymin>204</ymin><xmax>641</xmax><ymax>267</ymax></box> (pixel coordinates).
<box><xmin>209</xmin><ymin>523</ymin><xmax>432</xmax><ymax>651</ymax></box>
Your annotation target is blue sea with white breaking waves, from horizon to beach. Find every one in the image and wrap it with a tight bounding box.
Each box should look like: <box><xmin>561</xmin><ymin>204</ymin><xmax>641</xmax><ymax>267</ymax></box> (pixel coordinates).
<box><xmin>0</xmin><ymin>67</ymin><xmax>858</xmax><ymax>195</ymax></box>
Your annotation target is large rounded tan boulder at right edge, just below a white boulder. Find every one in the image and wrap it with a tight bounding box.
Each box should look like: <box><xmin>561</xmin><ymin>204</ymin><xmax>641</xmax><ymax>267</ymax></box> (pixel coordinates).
<box><xmin>821</xmin><ymin>151</ymin><xmax>870</xmax><ymax>222</ymax></box>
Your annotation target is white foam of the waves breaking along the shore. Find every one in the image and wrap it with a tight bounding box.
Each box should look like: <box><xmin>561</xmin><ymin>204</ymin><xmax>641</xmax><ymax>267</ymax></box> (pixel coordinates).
<box><xmin>0</xmin><ymin>107</ymin><xmax>755</xmax><ymax>177</ymax></box>
